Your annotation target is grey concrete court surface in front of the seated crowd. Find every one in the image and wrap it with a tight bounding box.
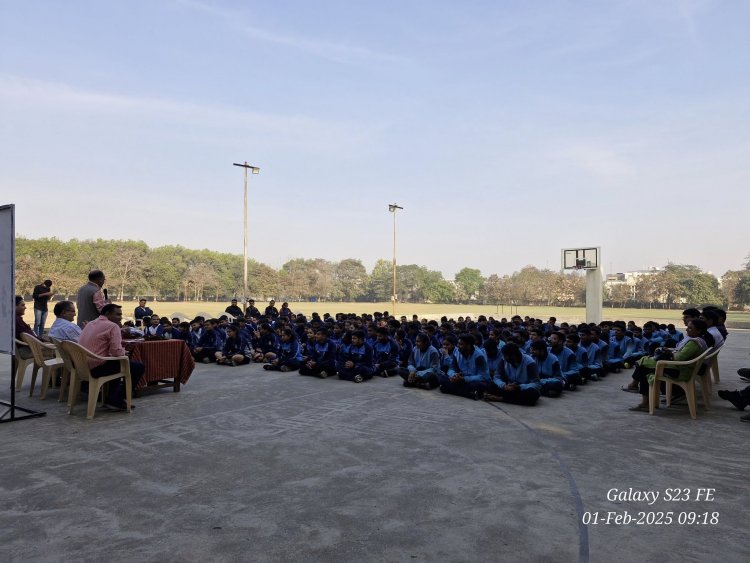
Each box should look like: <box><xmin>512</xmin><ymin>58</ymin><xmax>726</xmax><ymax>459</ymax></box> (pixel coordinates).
<box><xmin>0</xmin><ymin>330</ymin><xmax>750</xmax><ymax>562</ymax></box>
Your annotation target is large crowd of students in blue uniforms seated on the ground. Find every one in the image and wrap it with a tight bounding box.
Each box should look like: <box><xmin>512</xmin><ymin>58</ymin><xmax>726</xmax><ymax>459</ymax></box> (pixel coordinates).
<box><xmin>132</xmin><ymin>303</ymin><xmax>726</xmax><ymax>410</ymax></box>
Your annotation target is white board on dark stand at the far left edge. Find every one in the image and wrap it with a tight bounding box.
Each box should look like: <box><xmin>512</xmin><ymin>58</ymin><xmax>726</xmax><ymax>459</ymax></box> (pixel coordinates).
<box><xmin>0</xmin><ymin>205</ymin><xmax>16</xmax><ymax>354</ymax></box>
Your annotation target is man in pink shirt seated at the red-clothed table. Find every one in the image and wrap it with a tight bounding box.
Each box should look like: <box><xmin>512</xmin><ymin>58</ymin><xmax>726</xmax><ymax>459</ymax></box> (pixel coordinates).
<box><xmin>78</xmin><ymin>304</ymin><xmax>146</xmax><ymax>410</ymax></box>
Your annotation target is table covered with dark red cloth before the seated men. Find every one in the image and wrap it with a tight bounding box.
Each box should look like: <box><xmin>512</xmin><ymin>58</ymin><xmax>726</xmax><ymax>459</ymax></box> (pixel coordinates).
<box><xmin>123</xmin><ymin>339</ymin><xmax>195</xmax><ymax>393</ymax></box>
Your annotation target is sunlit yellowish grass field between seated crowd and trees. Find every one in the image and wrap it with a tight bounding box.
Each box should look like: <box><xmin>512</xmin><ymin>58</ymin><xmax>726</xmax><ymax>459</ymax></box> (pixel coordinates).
<box><xmin>24</xmin><ymin>301</ymin><xmax>750</xmax><ymax>328</ymax></box>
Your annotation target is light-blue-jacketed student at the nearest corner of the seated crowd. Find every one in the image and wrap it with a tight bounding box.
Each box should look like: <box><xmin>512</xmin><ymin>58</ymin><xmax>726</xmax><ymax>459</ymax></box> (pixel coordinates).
<box><xmin>484</xmin><ymin>342</ymin><xmax>540</xmax><ymax>406</ymax></box>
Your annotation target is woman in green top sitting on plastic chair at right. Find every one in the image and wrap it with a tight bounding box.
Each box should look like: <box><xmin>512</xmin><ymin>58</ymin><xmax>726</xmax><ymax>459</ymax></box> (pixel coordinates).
<box><xmin>629</xmin><ymin>319</ymin><xmax>714</xmax><ymax>412</ymax></box>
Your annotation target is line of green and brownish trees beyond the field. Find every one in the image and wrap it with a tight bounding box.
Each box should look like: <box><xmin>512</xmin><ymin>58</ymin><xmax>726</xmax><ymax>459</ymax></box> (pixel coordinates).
<box><xmin>16</xmin><ymin>237</ymin><xmax>750</xmax><ymax>308</ymax></box>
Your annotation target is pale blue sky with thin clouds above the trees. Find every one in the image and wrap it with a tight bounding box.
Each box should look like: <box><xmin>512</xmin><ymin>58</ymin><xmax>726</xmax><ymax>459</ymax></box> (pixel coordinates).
<box><xmin>0</xmin><ymin>0</ymin><xmax>750</xmax><ymax>277</ymax></box>
